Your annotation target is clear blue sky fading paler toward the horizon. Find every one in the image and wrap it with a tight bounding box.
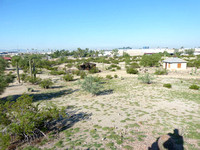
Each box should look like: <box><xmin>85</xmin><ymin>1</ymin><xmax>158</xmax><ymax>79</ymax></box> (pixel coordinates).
<box><xmin>0</xmin><ymin>0</ymin><xmax>200</xmax><ymax>49</ymax></box>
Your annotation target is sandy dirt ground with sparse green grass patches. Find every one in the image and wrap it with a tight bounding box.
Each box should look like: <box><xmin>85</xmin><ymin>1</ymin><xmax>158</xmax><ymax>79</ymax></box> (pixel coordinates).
<box><xmin>0</xmin><ymin>64</ymin><xmax>200</xmax><ymax>150</ymax></box>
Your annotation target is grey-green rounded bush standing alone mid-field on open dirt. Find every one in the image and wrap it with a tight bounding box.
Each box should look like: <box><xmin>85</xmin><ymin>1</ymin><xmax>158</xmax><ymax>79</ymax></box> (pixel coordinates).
<box><xmin>80</xmin><ymin>76</ymin><xmax>103</xmax><ymax>95</ymax></box>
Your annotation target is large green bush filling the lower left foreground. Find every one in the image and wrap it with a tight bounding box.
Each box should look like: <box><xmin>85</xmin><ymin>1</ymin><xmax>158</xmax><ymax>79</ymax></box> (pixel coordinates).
<box><xmin>0</xmin><ymin>95</ymin><xmax>66</xmax><ymax>149</ymax></box>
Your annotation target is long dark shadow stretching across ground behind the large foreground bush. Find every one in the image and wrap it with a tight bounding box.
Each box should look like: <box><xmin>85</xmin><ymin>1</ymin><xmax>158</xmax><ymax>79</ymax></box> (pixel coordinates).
<box><xmin>0</xmin><ymin>89</ymin><xmax>78</xmax><ymax>103</ymax></box>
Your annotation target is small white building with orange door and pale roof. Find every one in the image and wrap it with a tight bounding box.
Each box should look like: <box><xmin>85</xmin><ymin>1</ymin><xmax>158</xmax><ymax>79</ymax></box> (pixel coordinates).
<box><xmin>163</xmin><ymin>57</ymin><xmax>187</xmax><ymax>70</ymax></box>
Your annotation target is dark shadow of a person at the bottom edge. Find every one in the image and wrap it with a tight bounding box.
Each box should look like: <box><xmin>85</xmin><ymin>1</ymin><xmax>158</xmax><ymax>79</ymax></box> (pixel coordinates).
<box><xmin>149</xmin><ymin>129</ymin><xmax>184</xmax><ymax>150</ymax></box>
